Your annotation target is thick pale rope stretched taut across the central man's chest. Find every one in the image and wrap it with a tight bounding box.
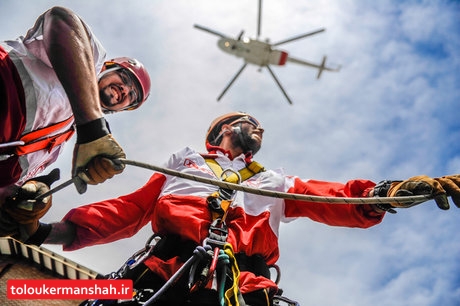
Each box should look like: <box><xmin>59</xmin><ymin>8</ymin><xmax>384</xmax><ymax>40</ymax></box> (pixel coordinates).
<box><xmin>119</xmin><ymin>159</ymin><xmax>432</xmax><ymax>204</ymax></box>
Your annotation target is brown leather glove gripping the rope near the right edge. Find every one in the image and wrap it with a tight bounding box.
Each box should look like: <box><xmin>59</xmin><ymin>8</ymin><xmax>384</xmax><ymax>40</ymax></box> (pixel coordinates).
<box><xmin>387</xmin><ymin>175</ymin><xmax>452</xmax><ymax>210</ymax></box>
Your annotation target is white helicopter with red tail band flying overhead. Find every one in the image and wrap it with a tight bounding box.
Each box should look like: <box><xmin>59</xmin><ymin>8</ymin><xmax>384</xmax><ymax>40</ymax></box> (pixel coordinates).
<box><xmin>194</xmin><ymin>0</ymin><xmax>341</xmax><ymax>105</ymax></box>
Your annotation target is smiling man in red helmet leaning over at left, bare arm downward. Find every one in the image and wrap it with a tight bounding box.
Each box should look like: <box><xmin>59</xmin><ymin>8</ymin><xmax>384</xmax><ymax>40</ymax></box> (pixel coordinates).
<box><xmin>0</xmin><ymin>7</ymin><xmax>154</xmax><ymax>240</ymax></box>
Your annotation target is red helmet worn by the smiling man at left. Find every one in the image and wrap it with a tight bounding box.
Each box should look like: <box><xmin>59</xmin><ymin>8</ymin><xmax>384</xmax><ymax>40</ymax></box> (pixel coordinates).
<box><xmin>101</xmin><ymin>57</ymin><xmax>151</xmax><ymax>110</ymax></box>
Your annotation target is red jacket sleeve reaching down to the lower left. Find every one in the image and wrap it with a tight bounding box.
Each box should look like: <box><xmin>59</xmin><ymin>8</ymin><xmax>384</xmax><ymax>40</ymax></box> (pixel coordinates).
<box><xmin>63</xmin><ymin>174</ymin><xmax>166</xmax><ymax>251</ymax></box>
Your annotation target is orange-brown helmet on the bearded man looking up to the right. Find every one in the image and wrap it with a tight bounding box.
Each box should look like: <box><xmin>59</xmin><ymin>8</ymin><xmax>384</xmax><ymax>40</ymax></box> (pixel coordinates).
<box><xmin>205</xmin><ymin>112</ymin><xmax>260</xmax><ymax>147</ymax></box>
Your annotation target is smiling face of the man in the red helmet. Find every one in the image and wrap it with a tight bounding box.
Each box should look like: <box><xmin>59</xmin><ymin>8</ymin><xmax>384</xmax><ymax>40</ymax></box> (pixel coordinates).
<box><xmin>99</xmin><ymin>69</ymin><xmax>139</xmax><ymax>111</ymax></box>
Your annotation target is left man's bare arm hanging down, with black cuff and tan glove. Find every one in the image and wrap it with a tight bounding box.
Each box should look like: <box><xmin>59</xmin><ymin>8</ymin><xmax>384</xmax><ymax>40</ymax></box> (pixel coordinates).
<box><xmin>43</xmin><ymin>7</ymin><xmax>126</xmax><ymax>193</ymax></box>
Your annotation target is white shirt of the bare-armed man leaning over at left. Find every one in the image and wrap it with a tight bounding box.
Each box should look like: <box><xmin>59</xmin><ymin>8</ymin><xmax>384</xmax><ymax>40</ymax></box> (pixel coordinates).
<box><xmin>0</xmin><ymin>8</ymin><xmax>106</xmax><ymax>189</ymax></box>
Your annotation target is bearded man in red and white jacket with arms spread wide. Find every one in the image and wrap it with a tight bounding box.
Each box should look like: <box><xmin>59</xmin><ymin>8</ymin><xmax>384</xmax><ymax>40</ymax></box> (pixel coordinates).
<box><xmin>4</xmin><ymin>112</ymin><xmax>460</xmax><ymax>306</ymax></box>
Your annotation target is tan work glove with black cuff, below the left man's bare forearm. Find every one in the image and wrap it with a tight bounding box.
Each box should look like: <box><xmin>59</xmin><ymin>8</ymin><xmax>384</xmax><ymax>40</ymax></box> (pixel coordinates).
<box><xmin>72</xmin><ymin>119</ymin><xmax>126</xmax><ymax>194</ymax></box>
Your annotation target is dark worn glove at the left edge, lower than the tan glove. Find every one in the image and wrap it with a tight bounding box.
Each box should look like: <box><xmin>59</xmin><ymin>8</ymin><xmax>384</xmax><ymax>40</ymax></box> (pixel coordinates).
<box><xmin>1</xmin><ymin>169</ymin><xmax>59</xmax><ymax>240</ymax></box>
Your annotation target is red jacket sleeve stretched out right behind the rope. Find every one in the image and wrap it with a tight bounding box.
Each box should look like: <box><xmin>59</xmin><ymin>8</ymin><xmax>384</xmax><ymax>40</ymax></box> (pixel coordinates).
<box><xmin>285</xmin><ymin>178</ymin><xmax>384</xmax><ymax>228</ymax></box>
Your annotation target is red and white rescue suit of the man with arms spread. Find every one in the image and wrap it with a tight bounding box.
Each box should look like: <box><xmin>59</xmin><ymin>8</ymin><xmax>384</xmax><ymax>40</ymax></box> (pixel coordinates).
<box><xmin>64</xmin><ymin>148</ymin><xmax>383</xmax><ymax>293</ymax></box>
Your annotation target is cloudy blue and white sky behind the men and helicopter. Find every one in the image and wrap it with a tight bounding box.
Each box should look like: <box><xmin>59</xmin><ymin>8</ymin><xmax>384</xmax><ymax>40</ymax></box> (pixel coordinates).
<box><xmin>0</xmin><ymin>0</ymin><xmax>460</xmax><ymax>306</ymax></box>
